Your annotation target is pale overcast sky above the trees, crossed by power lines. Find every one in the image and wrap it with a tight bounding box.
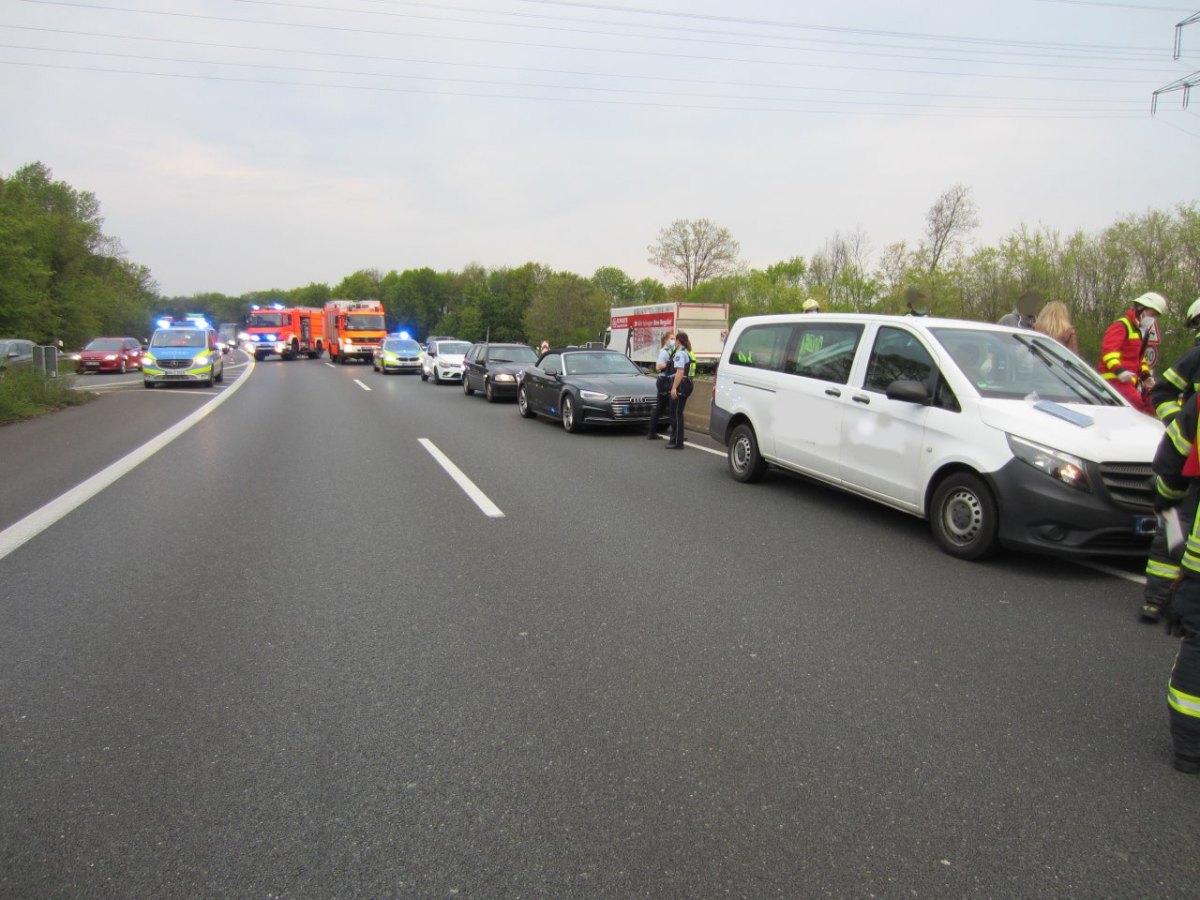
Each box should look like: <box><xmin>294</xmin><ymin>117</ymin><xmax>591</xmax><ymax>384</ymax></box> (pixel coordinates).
<box><xmin>0</xmin><ymin>0</ymin><xmax>1200</xmax><ymax>295</ymax></box>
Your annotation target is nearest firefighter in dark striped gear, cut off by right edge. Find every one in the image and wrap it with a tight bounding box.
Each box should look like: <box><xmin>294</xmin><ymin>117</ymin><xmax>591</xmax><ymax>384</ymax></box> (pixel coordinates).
<box><xmin>1154</xmin><ymin>397</ymin><xmax>1200</xmax><ymax>773</ymax></box>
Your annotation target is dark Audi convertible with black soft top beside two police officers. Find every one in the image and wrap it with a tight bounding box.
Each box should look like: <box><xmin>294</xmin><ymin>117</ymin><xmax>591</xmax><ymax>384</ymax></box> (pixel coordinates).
<box><xmin>517</xmin><ymin>347</ymin><xmax>658</xmax><ymax>433</ymax></box>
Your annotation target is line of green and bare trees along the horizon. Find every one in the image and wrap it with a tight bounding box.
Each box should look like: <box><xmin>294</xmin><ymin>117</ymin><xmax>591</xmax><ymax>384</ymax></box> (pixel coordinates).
<box><xmin>0</xmin><ymin>163</ymin><xmax>1200</xmax><ymax>369</ymax></box>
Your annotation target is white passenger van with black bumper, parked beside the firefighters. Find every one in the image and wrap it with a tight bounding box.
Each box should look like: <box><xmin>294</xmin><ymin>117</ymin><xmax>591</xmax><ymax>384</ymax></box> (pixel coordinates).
<box><xmin>709</xmin><ymin>313</ymin><xmax>1163</xmax><ymax>559</ymax></box>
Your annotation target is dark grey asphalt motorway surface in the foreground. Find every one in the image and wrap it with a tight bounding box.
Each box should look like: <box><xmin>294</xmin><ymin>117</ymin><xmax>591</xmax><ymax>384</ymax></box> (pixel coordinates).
<box><xmin>0</xmin><ymin>361</ymin><xmax>1200</xmax><ymax>898</ymax></box>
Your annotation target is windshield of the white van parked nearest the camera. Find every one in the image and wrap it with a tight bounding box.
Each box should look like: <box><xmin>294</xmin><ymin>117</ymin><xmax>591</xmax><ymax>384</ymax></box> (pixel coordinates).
<box><xmin>930</xmin><ymin>328</ymin><xmax>1121</xmax><ymax>406</ymax></box>
